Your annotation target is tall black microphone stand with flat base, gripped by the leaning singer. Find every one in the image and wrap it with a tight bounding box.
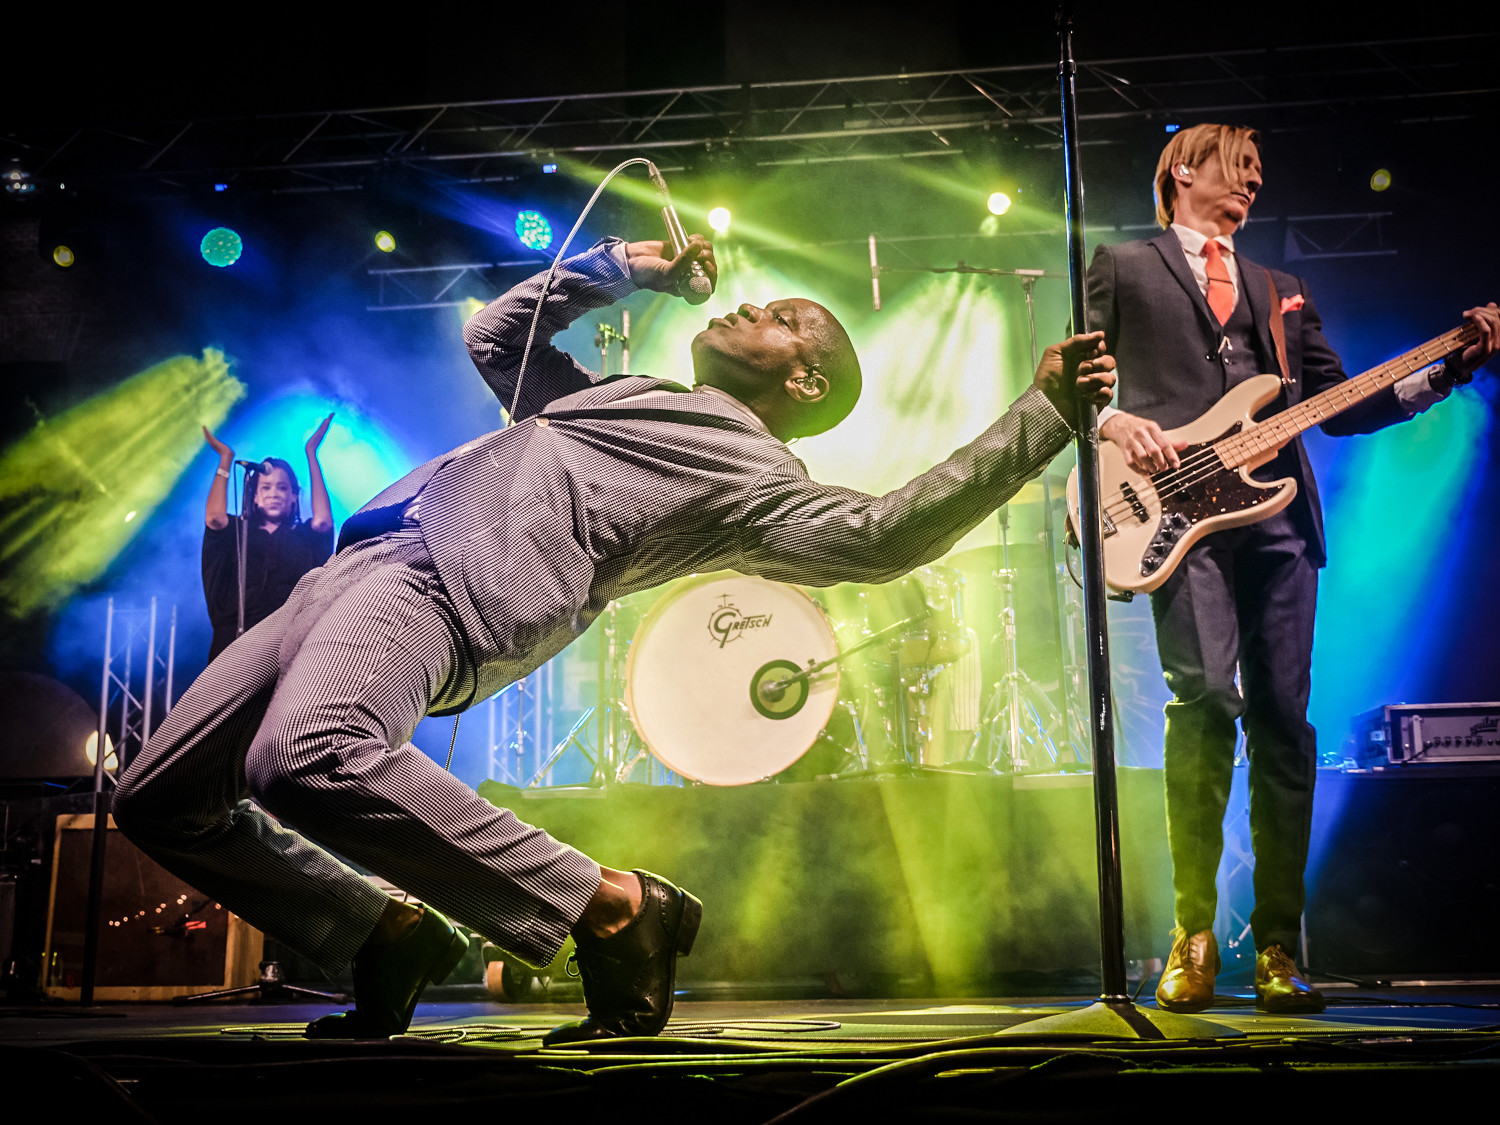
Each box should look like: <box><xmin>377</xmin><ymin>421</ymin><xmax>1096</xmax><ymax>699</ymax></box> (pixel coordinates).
<box><xmin>1008</xmin><ymin>3</ymin><xmax>1242</xmax><ymax>1040</ymax></box>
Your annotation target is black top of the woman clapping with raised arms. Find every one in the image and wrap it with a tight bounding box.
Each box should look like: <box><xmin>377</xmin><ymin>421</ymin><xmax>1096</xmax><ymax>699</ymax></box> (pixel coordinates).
<box><xmin>203</xmin><ymin>516</ymin><xmax>333</xmax><ymax>660</ymax></box>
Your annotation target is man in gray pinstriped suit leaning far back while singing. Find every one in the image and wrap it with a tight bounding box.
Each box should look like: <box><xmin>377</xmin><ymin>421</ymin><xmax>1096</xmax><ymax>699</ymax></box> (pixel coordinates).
<box><xmin>116</xmin><ymin>236</ymin><xmax>1115</xmax><ymax>1044</ymax></box>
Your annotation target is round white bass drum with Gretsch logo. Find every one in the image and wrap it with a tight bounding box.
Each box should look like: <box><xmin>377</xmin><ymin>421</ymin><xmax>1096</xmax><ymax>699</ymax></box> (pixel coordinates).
<box><xmin>626</xmin><ymin>575</ymin><xmax>839</xmax><ymax>785</ymax></box>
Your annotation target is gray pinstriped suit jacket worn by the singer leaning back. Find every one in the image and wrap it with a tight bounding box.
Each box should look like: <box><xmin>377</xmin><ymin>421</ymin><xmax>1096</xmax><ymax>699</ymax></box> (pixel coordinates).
<box><xmin>344</xmin><ymin>240</ymin><xmax>1070</xmax><ymax>699</ymax></box>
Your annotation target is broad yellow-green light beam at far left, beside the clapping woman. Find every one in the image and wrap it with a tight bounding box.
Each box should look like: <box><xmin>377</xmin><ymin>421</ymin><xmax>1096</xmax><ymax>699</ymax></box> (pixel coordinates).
<box><xmin>0</xmin><ymin>348</ymin><xmax>245</xmax><ymax>620</ymax></box>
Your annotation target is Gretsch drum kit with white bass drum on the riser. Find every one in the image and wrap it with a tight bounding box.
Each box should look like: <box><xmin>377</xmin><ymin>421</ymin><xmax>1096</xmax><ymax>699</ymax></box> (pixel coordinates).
<box><xmin>533</xmin><ymin>480</ymin><xmax>1088</xmax><ymax>786</ymax></box>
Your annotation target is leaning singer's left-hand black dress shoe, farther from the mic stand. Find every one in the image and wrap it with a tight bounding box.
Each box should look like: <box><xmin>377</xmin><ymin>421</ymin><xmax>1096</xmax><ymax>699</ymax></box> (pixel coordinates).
<box><xmin>303</xmin><ymin>906</ymin><xmax>468</xmax><ymax>1040</ymax></box>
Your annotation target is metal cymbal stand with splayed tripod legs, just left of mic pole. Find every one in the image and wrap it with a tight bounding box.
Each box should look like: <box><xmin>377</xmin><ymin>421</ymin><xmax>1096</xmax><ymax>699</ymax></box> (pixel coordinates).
<box><xmin>971</xmin><ymin>509</ymin><xmax>1061</xmax><ymax>774</ymax></box>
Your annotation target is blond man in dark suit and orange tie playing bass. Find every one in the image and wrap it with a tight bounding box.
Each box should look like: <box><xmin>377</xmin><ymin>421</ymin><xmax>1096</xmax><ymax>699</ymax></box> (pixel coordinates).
<box><xmin>1089</xmin><ymin>125</ymin><xmax>1500</xmax><ymax>1013</ymax></box>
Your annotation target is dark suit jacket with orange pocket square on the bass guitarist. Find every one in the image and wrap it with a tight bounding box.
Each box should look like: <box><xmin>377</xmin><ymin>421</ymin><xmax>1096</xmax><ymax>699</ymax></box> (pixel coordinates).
<box><xmin>1088</xmin><ymin>231</ymin><xmax>1407</xmax><ymax>564</ymax></box>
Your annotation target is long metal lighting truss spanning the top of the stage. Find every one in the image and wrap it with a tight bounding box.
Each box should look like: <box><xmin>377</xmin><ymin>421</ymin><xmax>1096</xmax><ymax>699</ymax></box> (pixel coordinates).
<box><xmin>0</xmin><ymin>33</ymin><xmax>1500</xmax><ymax>192</ymax></box>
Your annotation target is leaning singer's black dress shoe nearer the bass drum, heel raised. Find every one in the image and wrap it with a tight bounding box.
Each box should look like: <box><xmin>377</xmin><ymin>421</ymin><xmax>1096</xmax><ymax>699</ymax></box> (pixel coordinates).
<box><xmin>542</xmin><ymin>872</ymin><xmax>704</xmax><ymax>1047</ymax></box>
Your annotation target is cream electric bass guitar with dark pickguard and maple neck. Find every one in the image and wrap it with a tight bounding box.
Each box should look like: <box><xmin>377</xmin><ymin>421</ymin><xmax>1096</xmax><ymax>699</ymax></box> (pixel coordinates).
<box><xmin>1068</xmin><ymin>324</ymin><xmax>1479</xmax><ymax>594</ymax></box>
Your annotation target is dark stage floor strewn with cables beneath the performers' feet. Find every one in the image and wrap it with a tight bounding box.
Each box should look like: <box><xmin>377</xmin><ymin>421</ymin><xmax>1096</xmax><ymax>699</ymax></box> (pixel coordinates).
<box><xmin>0</xmin><ymin>984</ymin><xmax>1500</xmax><ymax>1125</ymax></box>
